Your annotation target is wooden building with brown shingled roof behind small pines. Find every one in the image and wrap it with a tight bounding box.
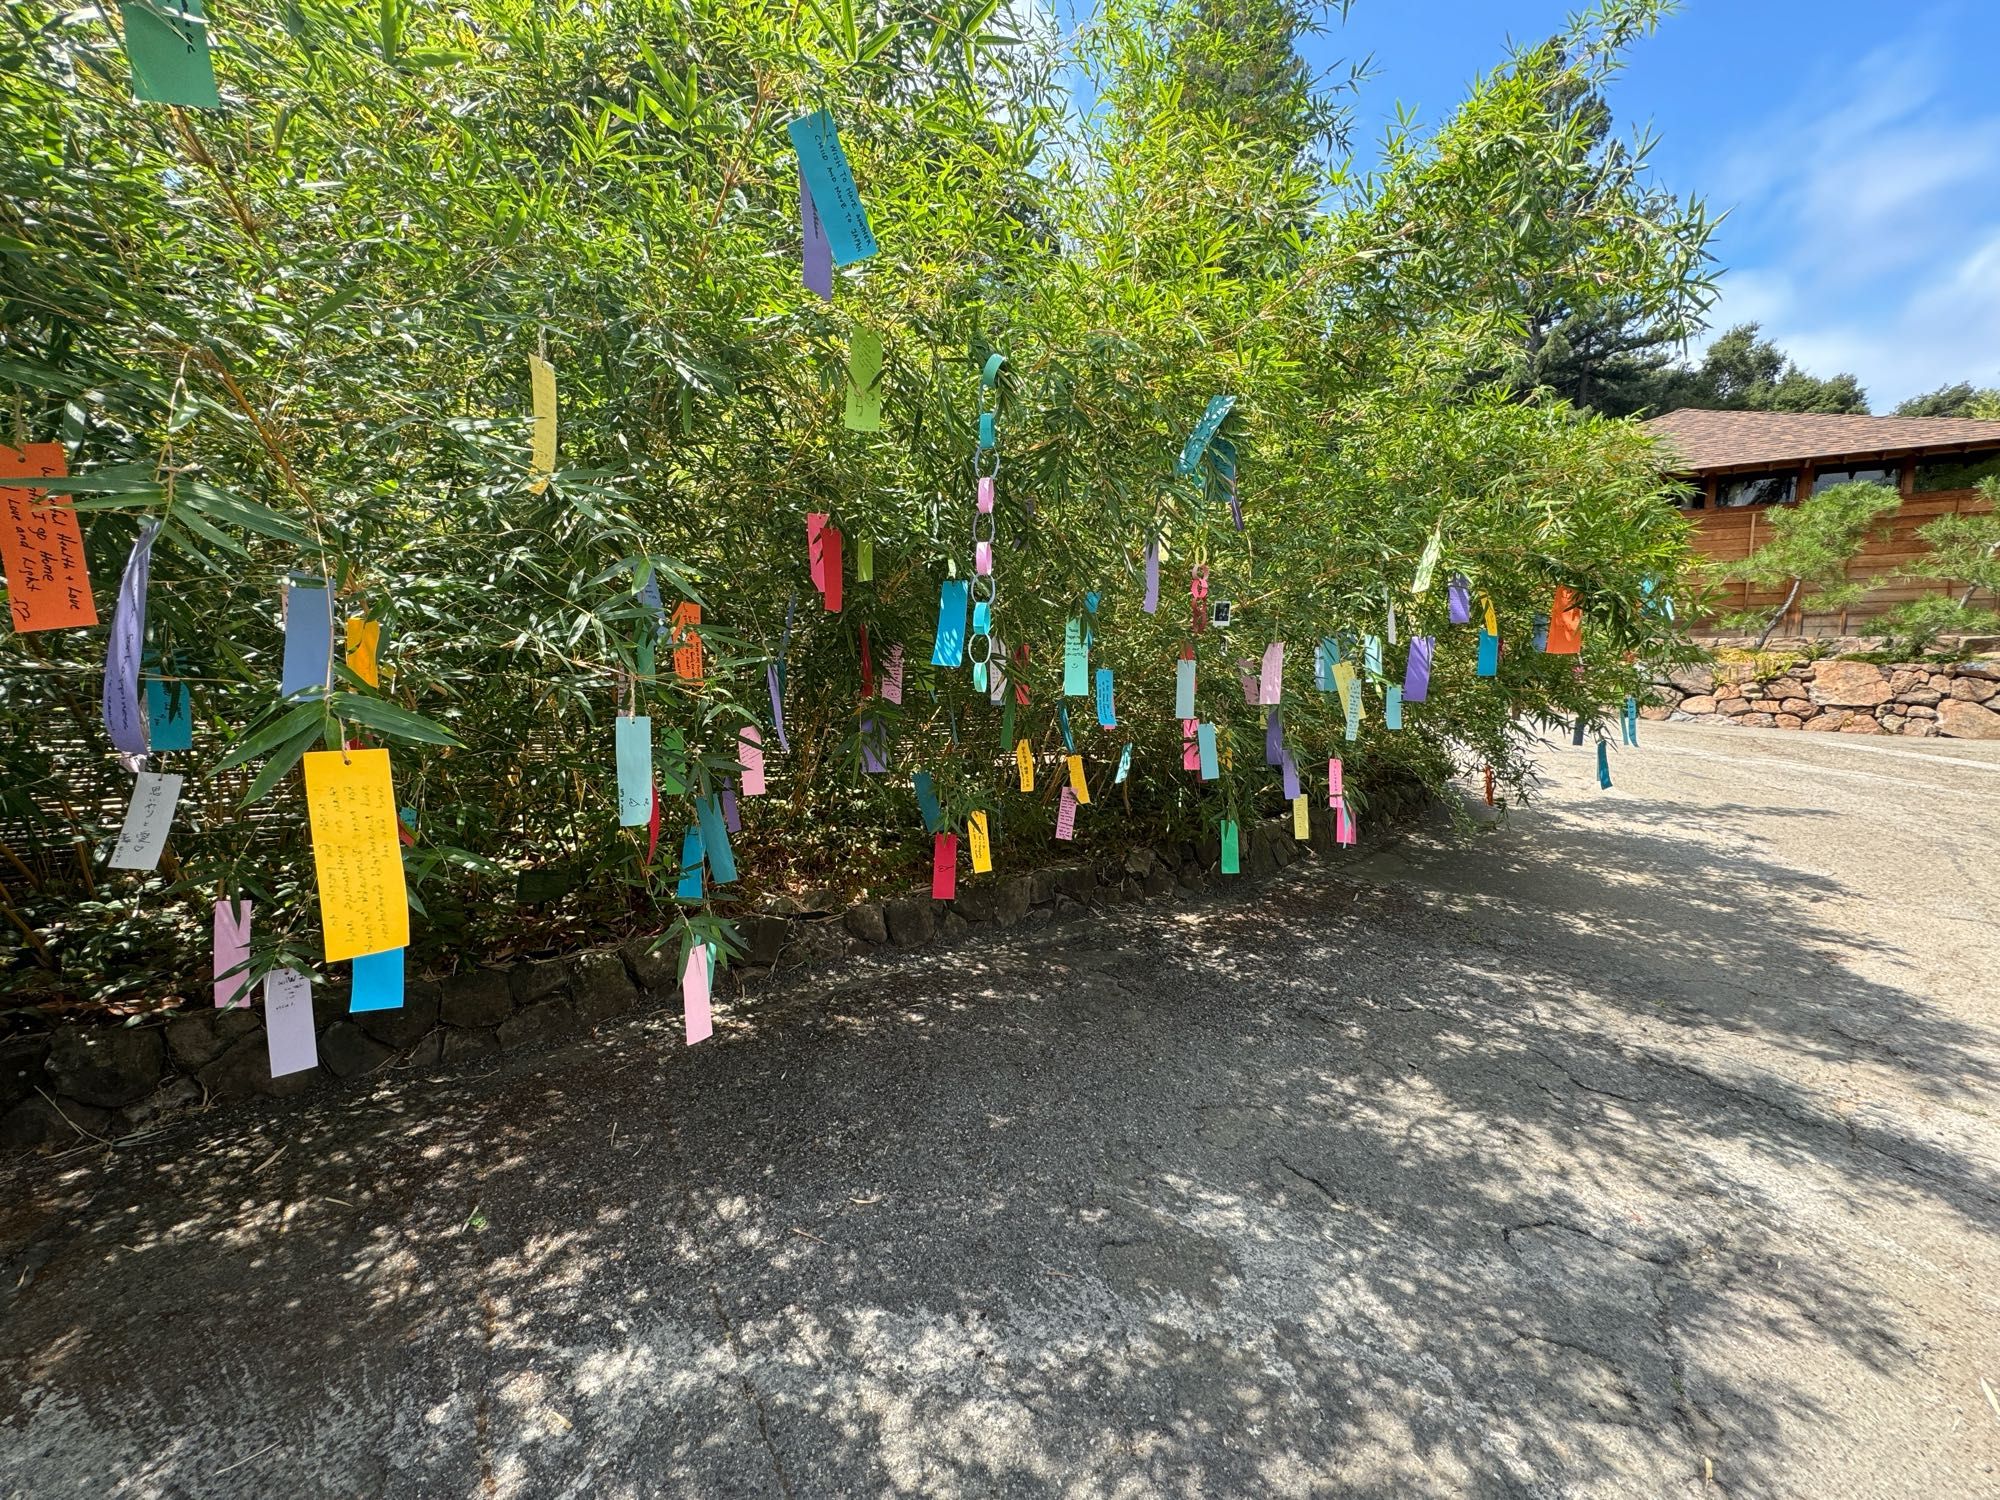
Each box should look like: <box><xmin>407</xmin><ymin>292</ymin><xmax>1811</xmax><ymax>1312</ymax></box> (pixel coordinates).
<box><xmin>1646</xmin><ymin>410</ymin><xmax>2000</xmax><ymax>636</ymax></box>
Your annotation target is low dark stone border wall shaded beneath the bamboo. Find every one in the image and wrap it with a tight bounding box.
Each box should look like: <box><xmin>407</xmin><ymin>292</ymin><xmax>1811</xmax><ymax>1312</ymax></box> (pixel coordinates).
<box><xmin>0</xmin><ymin>798</ymin><xmax>1394</xmax><ymax>1150</ymax></box>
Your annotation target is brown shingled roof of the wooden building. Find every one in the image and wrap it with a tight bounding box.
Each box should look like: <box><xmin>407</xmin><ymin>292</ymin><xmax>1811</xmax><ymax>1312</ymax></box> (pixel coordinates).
<box><xmin>1646</xmin><ymin>408</ymin><xmax>2000</xmax><ymax>474</ymax></box>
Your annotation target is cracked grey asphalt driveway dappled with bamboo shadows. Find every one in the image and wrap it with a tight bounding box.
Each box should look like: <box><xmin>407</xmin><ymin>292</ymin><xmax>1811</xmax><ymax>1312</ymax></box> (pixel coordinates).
<box><xmin>0</xmin><ymin>724</ymin><xmax>2000</xmax><ymax>1500</ymax></box>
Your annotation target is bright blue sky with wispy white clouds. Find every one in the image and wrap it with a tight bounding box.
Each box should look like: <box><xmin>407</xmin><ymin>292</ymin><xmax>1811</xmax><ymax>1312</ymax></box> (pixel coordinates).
<box><xmin>1304</xmin><ymin>0</ymin><xmax>2000</xmax><ymax>412</ymax></box>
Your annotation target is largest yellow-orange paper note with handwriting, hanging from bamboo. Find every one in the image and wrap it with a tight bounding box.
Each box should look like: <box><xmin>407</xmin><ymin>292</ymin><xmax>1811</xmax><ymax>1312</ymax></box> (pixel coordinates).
<box><xmin>306</xmin><ymin>750</ymin><xmax>408</xmax><ymax>964</ymax></box>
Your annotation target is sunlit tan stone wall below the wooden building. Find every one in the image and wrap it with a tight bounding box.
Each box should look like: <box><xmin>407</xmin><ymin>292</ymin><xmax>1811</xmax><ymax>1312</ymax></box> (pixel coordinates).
<box><xmin>1640</xmin><ymin>656</ymin><xmax>2000</xmax><ymax>740</ymax></box>
